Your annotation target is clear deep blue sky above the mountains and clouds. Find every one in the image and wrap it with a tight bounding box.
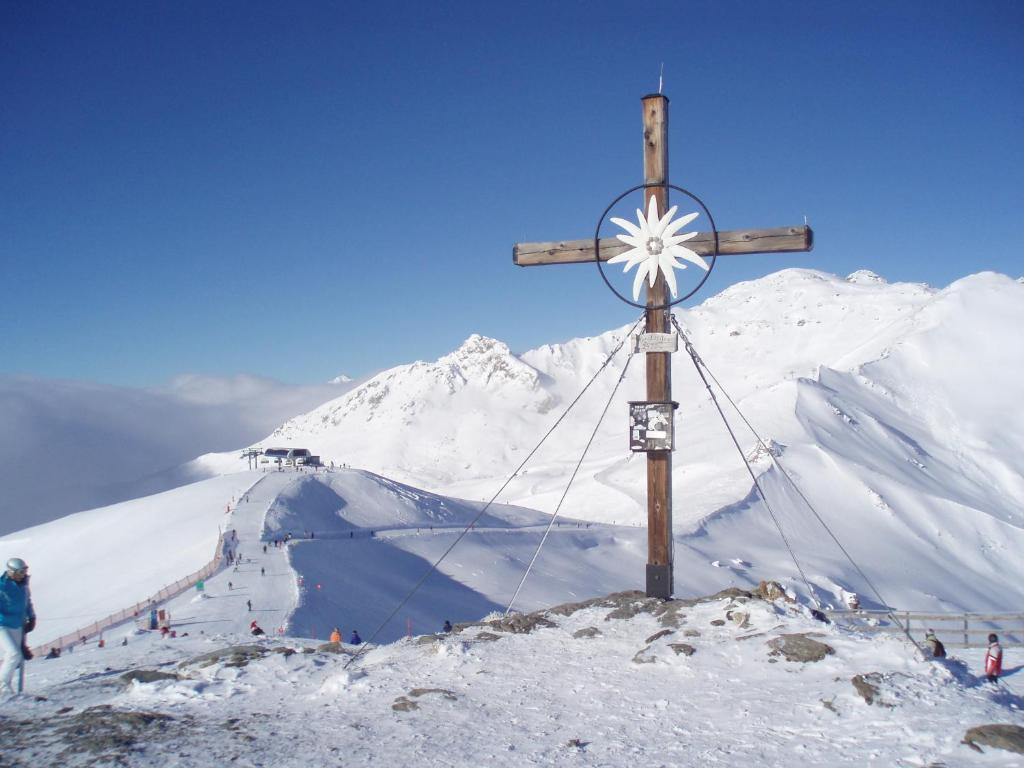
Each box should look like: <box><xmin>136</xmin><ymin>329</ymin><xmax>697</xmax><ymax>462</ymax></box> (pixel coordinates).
<box><xmin>0</xmin><ymin>0</ymin><xmax>1024</xmax><ymax>386</ymax></box>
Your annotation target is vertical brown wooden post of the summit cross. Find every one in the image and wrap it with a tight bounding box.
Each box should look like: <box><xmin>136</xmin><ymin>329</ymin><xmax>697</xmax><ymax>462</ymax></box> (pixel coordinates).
<box><xmin>642</xmin><ymin>93</ymin><xmax>673</xmax><ymax>598</ymax></box>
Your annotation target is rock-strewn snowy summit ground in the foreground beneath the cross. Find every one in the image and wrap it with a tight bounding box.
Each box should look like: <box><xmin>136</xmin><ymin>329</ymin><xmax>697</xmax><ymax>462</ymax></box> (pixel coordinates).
<box><xmin>9</xmin><ymin>599</ymin><xmax>1022</xmax><ymax>767</ymax></box>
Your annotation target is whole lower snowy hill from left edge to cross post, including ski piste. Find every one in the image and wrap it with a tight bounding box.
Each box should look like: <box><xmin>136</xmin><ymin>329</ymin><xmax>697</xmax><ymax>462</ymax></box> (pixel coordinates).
<box><xmin>0</xmin><ymin>470</ymin><xmax>645</xmax><ymax>646</ymax></box>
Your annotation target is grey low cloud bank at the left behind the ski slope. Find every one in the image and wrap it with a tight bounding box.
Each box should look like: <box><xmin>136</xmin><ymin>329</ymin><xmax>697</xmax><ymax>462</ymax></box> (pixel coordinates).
<box><xmin>0</xmin><ymin>375</ymin><xmax>351</xmax><ymax>535</ymax></box>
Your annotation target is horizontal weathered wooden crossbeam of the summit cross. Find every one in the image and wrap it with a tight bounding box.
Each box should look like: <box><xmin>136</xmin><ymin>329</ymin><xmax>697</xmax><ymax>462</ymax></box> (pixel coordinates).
<box><xmin>512</xmin><ymin>225</ymin><xmax>814</xmax><ymax>266</ymax></box>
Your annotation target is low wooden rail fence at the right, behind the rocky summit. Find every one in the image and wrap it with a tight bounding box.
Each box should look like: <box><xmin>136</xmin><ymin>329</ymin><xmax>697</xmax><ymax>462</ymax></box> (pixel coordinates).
<box><xmin>825</xmin><ymin>610</ymin><xmax>1024</xmax><ymax>648</ymax></box>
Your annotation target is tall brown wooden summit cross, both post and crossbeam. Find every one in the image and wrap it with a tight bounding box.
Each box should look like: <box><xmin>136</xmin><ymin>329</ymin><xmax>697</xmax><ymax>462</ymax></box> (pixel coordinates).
<box><xmin>512</xmin><ymin>93</ymin><xmax>813</xmax><ymax>598</ymax></box>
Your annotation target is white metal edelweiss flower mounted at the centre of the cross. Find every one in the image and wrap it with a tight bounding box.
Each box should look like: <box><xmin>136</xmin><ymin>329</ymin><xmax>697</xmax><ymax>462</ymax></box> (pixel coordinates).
<box><xmin>608</xmin><ymin>197</ymin><xmax>708</xmax><ymax>301</ymax></box>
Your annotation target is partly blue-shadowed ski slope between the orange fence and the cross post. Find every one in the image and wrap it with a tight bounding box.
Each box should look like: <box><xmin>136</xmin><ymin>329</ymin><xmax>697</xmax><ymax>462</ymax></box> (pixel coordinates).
<box><xmin>150</xmin><ymin>469</ymin><xmax>646</xmax><ymax>642</ymax></box>
